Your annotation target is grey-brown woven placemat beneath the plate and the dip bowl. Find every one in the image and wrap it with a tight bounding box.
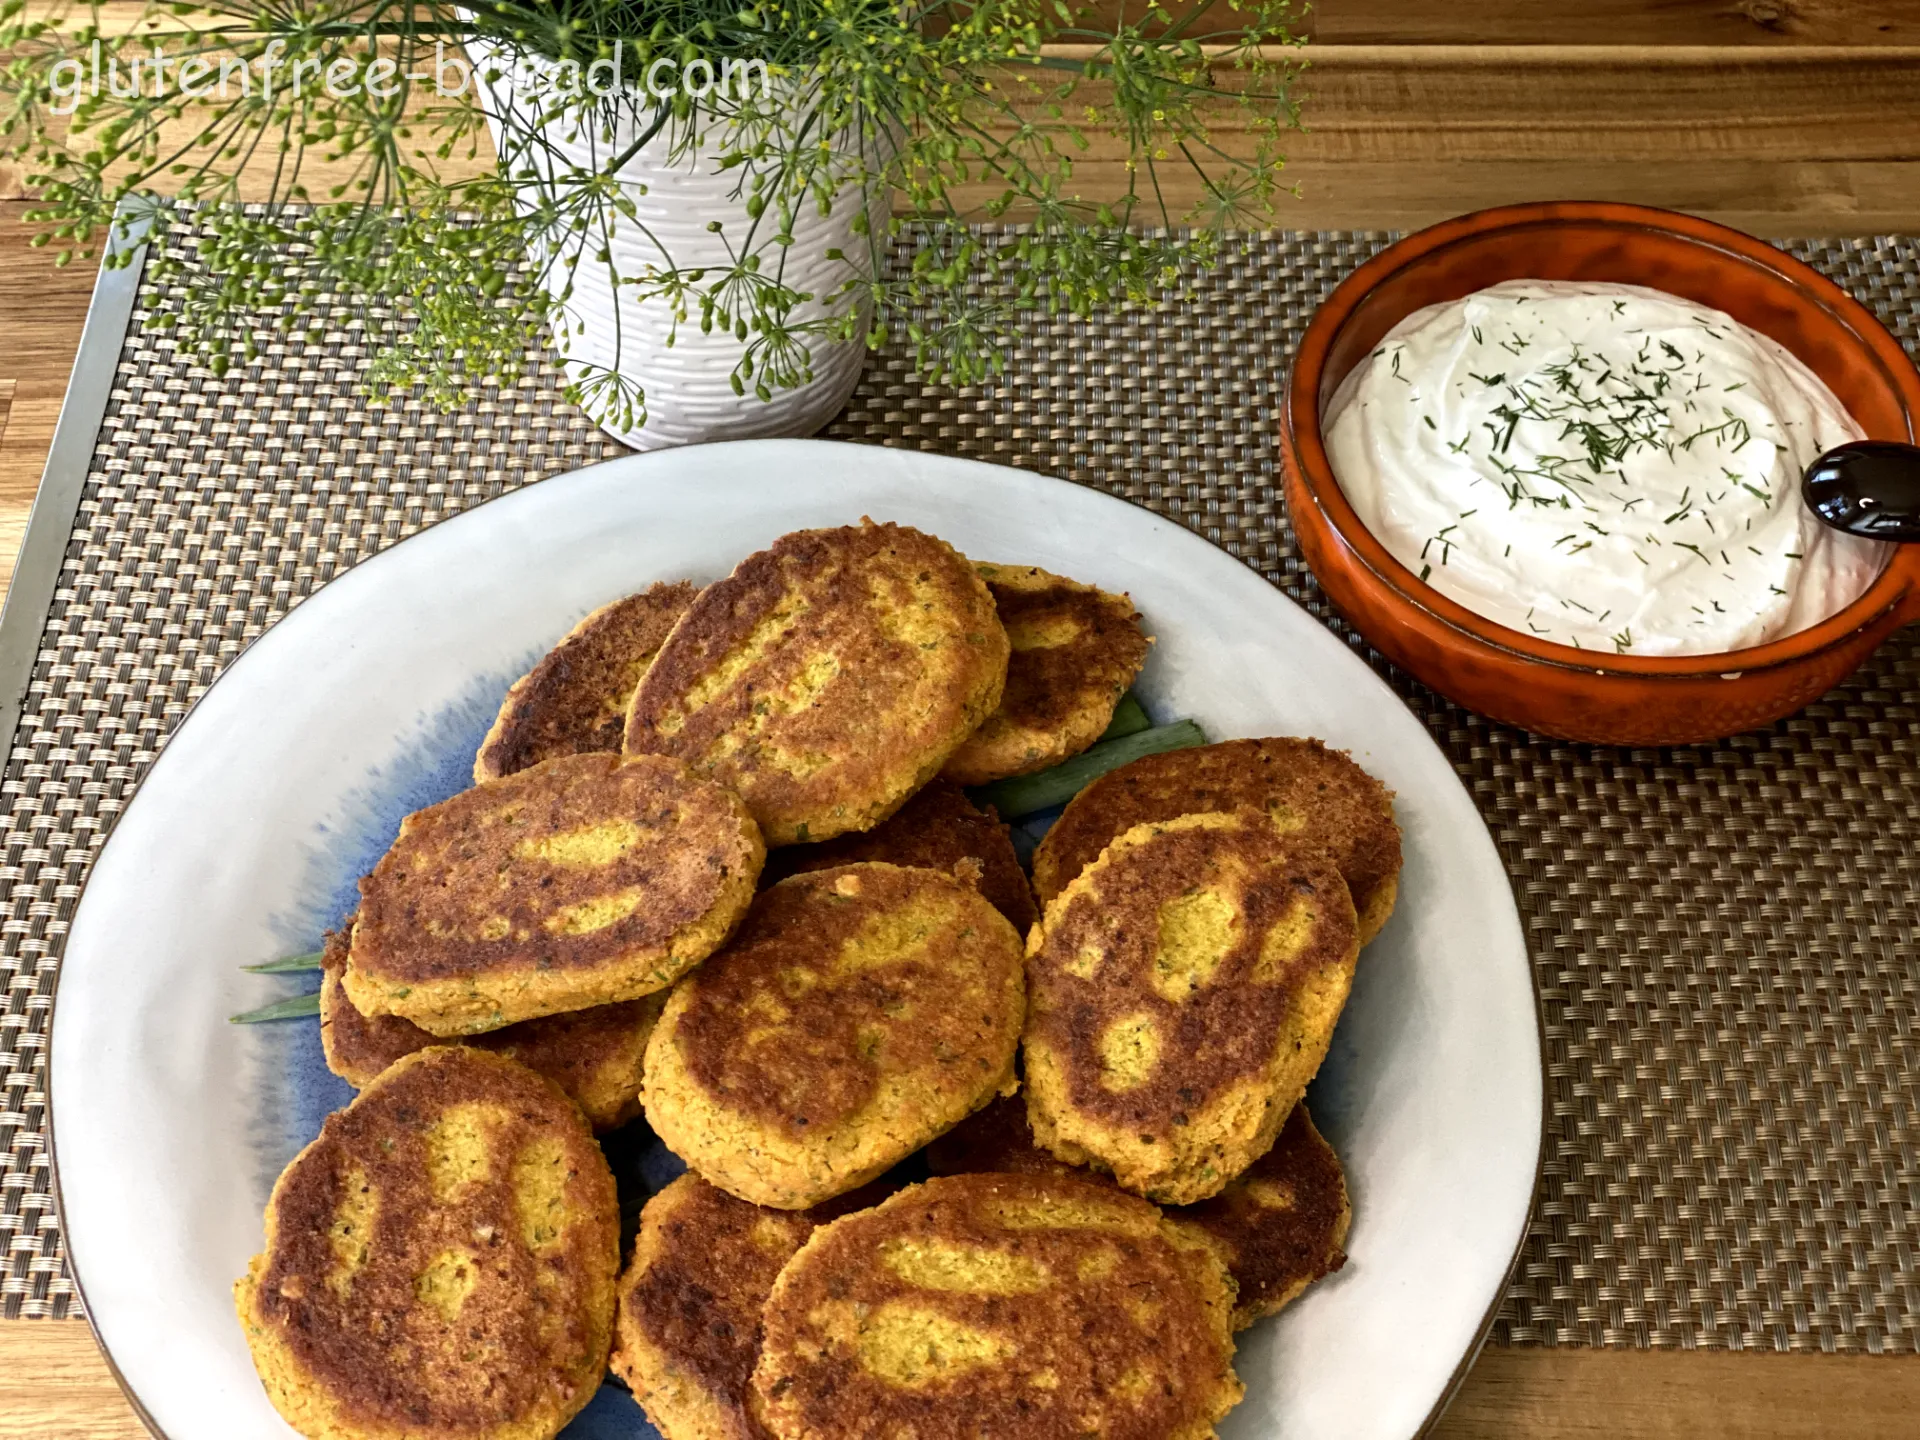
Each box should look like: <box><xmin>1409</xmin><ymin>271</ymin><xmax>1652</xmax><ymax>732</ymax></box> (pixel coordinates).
<box><xmin>0</xmin><ymin>222</ymin><xmax>1920</xmax><ymax>1352</ymax></box>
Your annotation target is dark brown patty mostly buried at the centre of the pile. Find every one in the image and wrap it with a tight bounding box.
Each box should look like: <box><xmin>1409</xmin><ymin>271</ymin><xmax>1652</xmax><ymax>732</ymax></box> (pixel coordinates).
<box><xmin>762</xmin><ymin>778</ymin><xmax>1041</xmax><ymax>935</ymax></box>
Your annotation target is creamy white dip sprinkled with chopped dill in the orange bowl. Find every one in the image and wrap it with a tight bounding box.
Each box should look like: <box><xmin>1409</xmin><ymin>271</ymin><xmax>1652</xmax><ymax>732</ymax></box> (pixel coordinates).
<box><xmin>1323</xmin><ymin>280</ymin><xmax>1889</xmax><ymax>655</ymax></box>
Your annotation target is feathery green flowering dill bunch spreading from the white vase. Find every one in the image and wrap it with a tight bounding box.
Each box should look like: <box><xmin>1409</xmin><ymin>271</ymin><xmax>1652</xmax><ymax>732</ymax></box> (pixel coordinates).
<box><xmin>0</xmin><ymin>0</ymin><xmax>1302</xmax><ymax>428</ymax></box>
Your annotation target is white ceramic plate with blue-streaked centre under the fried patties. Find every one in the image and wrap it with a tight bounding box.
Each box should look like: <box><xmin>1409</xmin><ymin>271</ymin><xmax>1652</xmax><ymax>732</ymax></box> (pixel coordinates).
<box><xmin>52</xmin><ymin>442</ymin><xmax>1542</xmax><ymax>1440</ymax></box>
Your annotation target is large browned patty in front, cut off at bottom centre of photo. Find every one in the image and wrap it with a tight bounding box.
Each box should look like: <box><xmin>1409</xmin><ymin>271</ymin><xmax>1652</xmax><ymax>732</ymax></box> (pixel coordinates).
<box><xmin>753</xmin><ymin>1175</ymin><xmax>1242</xmax><ymax>1440</ymax></box>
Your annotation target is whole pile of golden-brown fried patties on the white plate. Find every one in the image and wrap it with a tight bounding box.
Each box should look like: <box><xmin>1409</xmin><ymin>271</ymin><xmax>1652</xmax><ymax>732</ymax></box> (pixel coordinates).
<box><xmin>247</xmin><ymin>520</ymin><xmax>1400</xmax><ymax>1440</ymax></box>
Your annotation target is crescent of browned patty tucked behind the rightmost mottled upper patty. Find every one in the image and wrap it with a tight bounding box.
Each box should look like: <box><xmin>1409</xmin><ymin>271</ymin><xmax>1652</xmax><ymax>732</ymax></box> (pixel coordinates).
<box><xmin>1033</xmin><ymin>735</ymin><xmax>1400</xmax><ymax>945</ymax></box>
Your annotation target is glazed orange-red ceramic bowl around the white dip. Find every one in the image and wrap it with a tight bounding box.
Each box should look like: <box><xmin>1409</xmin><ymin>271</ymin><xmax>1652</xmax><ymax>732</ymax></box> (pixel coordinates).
<box><xmin>1281</xmin><ymin>204</ymin><xmax>1920</xmax><ymax>745</ymax></box>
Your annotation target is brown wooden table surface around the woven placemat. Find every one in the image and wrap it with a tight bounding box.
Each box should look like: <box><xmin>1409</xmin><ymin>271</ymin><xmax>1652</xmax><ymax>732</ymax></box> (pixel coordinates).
<box><xmin>0</xmin><ymin>0</ymin><xmax>1920</xmax><ymax>1440</ymax></box>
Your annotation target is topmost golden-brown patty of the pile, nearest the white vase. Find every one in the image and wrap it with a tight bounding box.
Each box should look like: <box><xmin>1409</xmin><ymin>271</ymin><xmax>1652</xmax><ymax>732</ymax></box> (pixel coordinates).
<box><xmin>626</xmin><ymin>520</ymin><xmax>1008</xmax><ymax>845</ymax></box>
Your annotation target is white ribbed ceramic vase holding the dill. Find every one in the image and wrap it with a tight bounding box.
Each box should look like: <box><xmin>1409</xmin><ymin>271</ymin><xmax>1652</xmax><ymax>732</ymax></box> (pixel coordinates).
<box><xmin>468</xmin><ymin>46</ymin><xmax>885</xmax><ymax>449</ymax></box>
